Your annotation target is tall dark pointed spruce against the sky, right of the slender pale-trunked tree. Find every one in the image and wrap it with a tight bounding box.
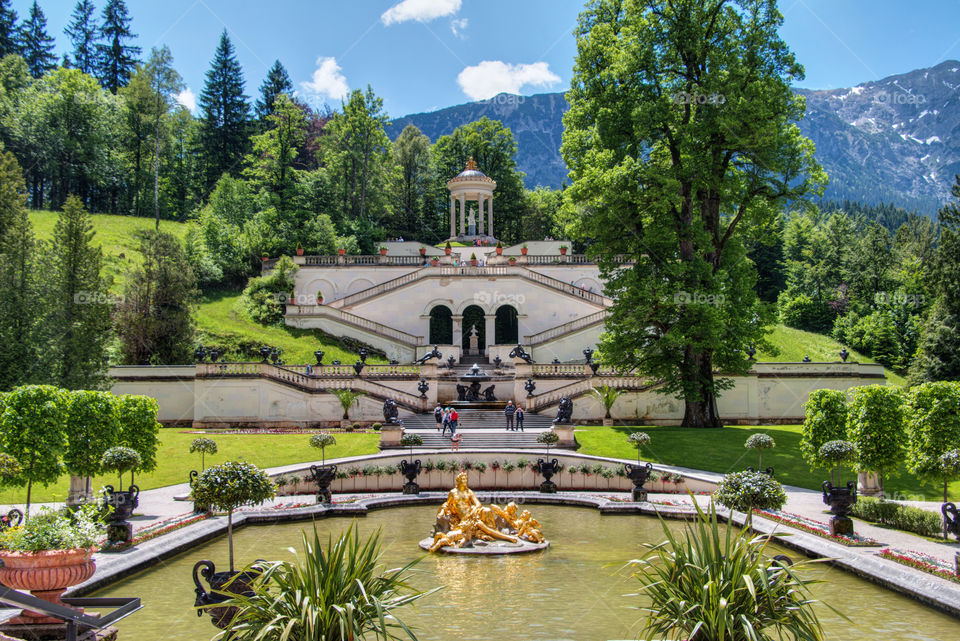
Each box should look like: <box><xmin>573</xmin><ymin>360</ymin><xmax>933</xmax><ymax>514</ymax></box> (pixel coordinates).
<box><xmin>200</xmin><ymin>30</ymin><xmax>250</xmax><ymax>191</ymax></box>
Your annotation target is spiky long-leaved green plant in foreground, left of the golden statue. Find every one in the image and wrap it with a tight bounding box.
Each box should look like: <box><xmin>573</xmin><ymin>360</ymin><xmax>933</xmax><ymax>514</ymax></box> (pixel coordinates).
<box><xmin>222</xmin><ymin>525</ymin><xmax>436</xmax><ymax>641</ymax></box>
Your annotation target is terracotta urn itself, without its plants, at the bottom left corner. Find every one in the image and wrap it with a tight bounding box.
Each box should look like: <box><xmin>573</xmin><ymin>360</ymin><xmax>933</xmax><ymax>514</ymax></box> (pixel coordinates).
<box><xmin>0</xmin><ymin>547</ymin><xmax>97</xmax><ymax>625</ymax></box>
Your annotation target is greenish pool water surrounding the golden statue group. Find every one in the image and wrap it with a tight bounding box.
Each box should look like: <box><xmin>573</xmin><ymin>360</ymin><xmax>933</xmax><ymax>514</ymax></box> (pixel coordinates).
<box><xmin>96</xmin><ymin>506</ymin><xmax>960</xmax><ymax>641</ymax></box>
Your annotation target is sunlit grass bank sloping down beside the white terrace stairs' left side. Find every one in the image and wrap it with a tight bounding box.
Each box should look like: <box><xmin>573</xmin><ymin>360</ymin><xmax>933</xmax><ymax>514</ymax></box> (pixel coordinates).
<box><xmin>197</xmin><ymin>291</ymin><xmax>387</xmax><ymax>365</ymax></box>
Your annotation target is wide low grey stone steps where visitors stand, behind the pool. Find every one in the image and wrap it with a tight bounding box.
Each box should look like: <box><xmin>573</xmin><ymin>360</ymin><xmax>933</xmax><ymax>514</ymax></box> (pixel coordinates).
<box><xmin>403</xmin><ymin>409</ymin><xmax>552</xmax><ymax>449</ymax></box>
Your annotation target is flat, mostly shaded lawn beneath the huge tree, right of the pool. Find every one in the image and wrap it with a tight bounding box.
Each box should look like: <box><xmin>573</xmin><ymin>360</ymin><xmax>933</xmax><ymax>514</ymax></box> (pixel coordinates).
<box><xmin>576</xmin><ymin>425</ymin><xmax>960</xmax><ymax>501</ymax></box>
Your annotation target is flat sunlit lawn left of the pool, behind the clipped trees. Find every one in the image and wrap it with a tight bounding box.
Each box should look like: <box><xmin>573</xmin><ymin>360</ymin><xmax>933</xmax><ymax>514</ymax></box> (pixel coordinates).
<box><xmin>0</xmin><ymin>428</ymin><xmax>380</xmax><ymax>503</ymax></box>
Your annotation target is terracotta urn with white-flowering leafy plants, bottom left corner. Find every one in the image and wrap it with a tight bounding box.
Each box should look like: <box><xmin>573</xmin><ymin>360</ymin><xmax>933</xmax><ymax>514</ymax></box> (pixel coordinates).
<box><xmin>0</xmin><ymin>503</ymin><xmax>103</xmax><ymax>624</ymax></box>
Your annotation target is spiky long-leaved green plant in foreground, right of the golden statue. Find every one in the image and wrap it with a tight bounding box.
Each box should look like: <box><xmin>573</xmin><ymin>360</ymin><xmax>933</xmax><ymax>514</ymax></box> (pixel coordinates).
<box><xmin>630</xmin><ymin>502</ymin><xmax>846</xmax><ymax>641</ymax></box>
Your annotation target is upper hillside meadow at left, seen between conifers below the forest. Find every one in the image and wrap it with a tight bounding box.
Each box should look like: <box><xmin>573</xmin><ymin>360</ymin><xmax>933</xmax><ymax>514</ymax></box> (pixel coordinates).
<box><xmin>30</xmin><ymin>211</ymin><xmax>186</xmax><ymax>291</ymax></box>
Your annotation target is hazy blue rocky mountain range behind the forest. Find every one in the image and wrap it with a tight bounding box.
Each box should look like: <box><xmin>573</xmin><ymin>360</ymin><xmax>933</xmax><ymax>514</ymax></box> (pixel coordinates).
<box><xmin>387</xmin><ymin>60</ymin><xmax>960</xmax><ymax>215</ymax></box>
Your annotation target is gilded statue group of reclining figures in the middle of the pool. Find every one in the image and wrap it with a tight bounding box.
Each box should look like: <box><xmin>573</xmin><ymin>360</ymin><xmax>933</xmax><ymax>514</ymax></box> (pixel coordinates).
<box><xmin>429</xmin><ymin>472</ymin><xmax>545</xmax><ymax>552</ymax></box>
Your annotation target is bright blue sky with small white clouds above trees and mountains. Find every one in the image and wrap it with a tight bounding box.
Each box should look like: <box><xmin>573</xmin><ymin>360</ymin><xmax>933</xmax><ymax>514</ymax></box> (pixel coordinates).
<box><xmin>13</xmin><ymin>0</ymin><xmax>960</xmax><ymax>116</ymax></box>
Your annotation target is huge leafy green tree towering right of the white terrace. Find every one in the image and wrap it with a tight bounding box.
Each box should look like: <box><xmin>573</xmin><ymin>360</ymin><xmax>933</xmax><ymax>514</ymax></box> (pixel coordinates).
<box><xmin>562</xmin><ymin>0</ymin><xmax>823</xmax><ymax>427</ymax></box>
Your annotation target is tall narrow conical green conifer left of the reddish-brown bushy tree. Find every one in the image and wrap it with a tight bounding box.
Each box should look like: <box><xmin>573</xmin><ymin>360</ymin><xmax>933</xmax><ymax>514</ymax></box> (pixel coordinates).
<box><xmin>44</xmin><ymin>196</ymin><xmax>111</xmax><ymax>389</ymax></box>
